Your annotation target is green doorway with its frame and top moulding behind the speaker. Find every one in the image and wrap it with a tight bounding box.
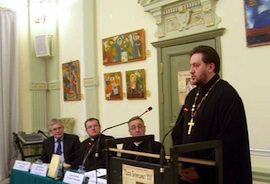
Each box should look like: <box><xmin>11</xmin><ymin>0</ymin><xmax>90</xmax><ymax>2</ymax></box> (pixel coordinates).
<box><xmin>152</xmin><ymin>29</ymin><xmax>224</xmax><ymax>155</ymax></box>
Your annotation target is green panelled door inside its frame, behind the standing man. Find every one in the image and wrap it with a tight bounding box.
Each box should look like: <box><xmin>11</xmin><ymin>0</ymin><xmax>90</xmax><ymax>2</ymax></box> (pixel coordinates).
<box><xmin>159</xmin><ymin>39</ymin><xmax>216</xmax><ymax>154</ymax></box>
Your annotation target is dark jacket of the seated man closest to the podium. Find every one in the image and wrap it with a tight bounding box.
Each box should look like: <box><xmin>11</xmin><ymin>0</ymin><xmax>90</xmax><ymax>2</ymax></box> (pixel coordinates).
<box><xmin>121</xmin><ymin>141</ymin><xmax>161</xmax><ymax>164</ymax></box>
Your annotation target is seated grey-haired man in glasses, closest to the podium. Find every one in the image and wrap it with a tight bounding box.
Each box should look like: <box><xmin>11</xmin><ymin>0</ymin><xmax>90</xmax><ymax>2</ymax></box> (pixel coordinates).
<box><xmin>122</xmin><ymin>116</ymin><xmax>161</xmax><ymax>164</ymax></box>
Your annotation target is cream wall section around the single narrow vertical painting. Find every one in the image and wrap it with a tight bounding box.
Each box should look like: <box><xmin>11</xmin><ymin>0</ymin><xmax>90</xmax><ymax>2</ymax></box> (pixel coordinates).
<box><xmin>59</xmin><ymin>0</ymin><xmax>86</xmax><ymax>139</ymax></box>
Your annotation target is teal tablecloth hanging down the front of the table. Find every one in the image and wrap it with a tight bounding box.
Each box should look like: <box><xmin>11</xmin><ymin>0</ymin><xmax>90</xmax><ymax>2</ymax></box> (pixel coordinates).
<box><xmin>10</xmin><ymin>169</ymin><xmax>66</xmax><ymax>184</ymax></box>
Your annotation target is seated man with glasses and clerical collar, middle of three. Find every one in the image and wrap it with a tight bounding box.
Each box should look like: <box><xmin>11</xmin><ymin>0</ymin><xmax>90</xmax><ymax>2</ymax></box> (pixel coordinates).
<box><xmin>77</xmin><ymin>118</ymin><xmax>116</xmax><ymax>171</ymax></box>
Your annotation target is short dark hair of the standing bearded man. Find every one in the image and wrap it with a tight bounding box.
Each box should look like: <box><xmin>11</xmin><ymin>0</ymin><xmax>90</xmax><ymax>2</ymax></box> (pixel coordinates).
<box><xmin>190</xmin><ymin>45</ymin><xmax>220</xmax><ymax>74</ymax></box>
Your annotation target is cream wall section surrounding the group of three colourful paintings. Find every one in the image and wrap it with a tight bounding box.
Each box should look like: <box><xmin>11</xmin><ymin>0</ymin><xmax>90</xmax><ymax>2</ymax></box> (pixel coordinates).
<box><xmin>97</xmin><ymin>0</ymin><xmax>159</xmax><ymax>140</ymax></box>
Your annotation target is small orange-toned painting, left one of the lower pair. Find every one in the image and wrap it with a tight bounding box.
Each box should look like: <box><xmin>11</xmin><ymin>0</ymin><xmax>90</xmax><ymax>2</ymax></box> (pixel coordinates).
<box><xmin>104</xmin><ymin>72</ymin><xmax>123</xmax><ymax>100</ymax></box>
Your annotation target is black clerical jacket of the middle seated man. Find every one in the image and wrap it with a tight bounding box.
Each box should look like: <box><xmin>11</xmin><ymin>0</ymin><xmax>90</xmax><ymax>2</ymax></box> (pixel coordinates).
<box><xmin>76</xmin><ymin>134</ymin><xmax>116</xmax><ymax>171</ymax></box>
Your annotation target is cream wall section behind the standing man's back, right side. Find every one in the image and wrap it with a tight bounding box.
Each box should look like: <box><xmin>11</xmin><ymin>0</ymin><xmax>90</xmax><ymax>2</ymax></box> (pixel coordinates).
<box><xmin>217</xmin><ymin>0</ymin><xmax>270</xmax><ymax>171</ymax></box>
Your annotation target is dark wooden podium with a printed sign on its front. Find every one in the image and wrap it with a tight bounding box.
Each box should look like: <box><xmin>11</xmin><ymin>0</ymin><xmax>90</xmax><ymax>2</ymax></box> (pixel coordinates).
<box><xmin>105</xmin><ymin>135</ymin><xmax>223</xmax><ymax>184</ymax></box>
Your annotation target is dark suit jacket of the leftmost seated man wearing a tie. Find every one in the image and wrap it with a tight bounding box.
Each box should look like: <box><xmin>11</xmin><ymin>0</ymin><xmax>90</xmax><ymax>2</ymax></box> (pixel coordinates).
<box><xmin>41</xmin><ymin>133</ymin><xmax>80</xmax><ymax>168</ymax></box>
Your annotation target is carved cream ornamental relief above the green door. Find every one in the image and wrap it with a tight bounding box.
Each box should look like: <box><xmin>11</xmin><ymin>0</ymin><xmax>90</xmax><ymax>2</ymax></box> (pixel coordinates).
<box><xmin>138</xmin><ymin>0</ymin><xmax>221</xmax><ymax>39</ymax></box>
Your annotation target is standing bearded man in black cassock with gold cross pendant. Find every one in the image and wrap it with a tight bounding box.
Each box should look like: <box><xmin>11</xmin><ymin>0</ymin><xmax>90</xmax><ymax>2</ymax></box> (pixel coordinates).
<box><xmin>172</xmin><ymin>46</ymin><xmax>252</xmax><ymax>184</ymax></box>
